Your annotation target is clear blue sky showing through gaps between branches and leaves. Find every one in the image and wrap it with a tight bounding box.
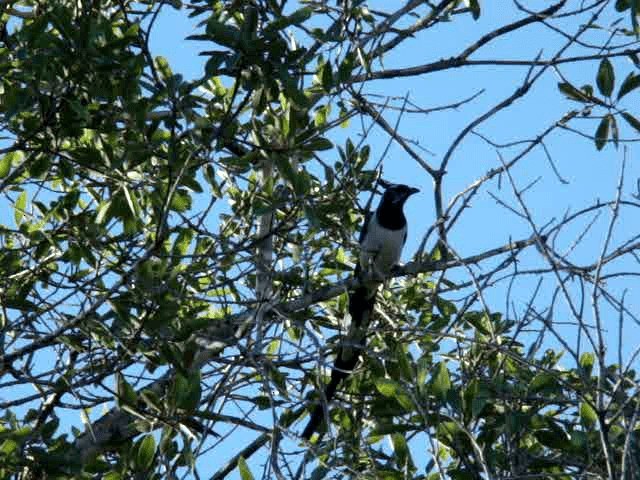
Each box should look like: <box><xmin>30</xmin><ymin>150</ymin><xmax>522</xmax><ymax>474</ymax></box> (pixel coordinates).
<box><xmin>1</xmin><ymin>0</ymin><xmax>640</xmax><ymax>476</ymax></box>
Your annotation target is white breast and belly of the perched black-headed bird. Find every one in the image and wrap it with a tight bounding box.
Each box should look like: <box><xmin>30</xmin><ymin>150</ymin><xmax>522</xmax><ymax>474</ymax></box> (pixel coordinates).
<box><xmin>360</xmin><ymin>214</ymin><xmax>407</xmax><ymax>277</ymax></box>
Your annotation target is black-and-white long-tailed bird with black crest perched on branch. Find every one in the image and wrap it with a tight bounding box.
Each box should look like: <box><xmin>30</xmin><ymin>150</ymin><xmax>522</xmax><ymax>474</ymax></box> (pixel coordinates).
<box><xmin>302</xmin><ymin>182</ymin><xmax>420</xmax><ymax>440</ymax></box>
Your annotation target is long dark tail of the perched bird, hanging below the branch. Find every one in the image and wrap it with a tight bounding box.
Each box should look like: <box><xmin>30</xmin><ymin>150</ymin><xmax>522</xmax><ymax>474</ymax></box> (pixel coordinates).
<box><xmin>302</xmin><ymin>285</ymin><xmax>377</xmax><ymax>440</ymax></box>
